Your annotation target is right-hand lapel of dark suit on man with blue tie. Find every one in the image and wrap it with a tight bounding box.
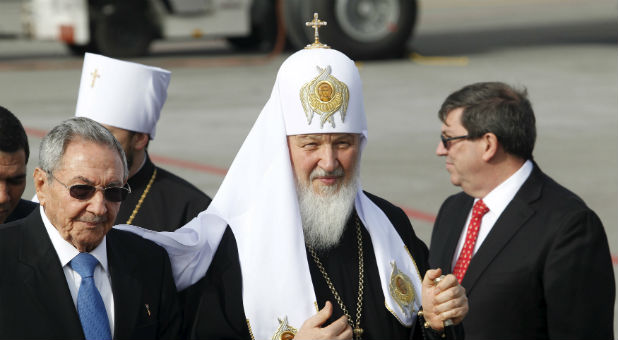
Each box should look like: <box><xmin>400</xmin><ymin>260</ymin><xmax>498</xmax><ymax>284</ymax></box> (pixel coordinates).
<box><xmin>107</xmin><ymin>229</ymin><xmax>146</xmax><ymax>339</ymax></box>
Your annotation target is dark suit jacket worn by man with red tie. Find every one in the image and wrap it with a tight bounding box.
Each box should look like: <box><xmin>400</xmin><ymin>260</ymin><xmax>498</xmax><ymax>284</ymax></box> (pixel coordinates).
<box><xmin>429</xmin><ymin>164</ymin><xmax>615</xmax><ymax>339</ymax></box>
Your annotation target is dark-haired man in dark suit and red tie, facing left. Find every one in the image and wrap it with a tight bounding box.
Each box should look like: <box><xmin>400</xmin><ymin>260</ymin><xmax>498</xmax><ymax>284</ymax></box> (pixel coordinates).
<box><xmin>429</xmin><ymin>83</ymin><xmax>615</xmax><ymax>339</ymax></box>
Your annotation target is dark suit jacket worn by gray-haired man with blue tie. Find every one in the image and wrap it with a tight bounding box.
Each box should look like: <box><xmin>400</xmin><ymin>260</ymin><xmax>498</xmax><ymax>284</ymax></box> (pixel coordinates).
<box><xmin>0</xmin><ymin>209</ymin><xmax>181</xmax><ymax>339</ymax></box>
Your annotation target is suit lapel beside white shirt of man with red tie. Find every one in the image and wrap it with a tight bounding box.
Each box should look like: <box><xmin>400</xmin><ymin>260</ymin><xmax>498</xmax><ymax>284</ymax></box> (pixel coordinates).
<box><xmin>461</xmin><ymin>164</ymin><xmax>543</xmax><ymax>293</ymax></box>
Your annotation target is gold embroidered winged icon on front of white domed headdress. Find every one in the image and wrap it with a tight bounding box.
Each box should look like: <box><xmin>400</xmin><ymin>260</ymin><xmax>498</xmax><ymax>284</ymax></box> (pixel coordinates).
<box><xmin>300</xmin><ymin>65</ymin><xmax>350</xmax><ymax>128</ymax></box>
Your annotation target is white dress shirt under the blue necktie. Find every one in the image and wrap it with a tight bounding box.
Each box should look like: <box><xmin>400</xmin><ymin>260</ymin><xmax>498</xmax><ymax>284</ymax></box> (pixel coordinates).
<box><xmin>41</xmin><ymin>206</ymin><xmax>114</xmax><ymax>338</ymax></box>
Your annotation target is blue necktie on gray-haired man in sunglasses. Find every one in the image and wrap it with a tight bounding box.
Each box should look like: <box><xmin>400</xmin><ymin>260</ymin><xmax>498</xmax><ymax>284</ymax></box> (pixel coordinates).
<box><xmin>70</xmin><ymin>253</ymin><xmax>112</xmax><ymax>340</ymax></box>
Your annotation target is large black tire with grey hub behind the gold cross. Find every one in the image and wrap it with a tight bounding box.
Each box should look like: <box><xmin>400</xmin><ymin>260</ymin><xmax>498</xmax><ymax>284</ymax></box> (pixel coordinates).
<box><xmin>288</xmin><ymin>0</ymin><xmax>417</xmax><ymax>60</ymax></box>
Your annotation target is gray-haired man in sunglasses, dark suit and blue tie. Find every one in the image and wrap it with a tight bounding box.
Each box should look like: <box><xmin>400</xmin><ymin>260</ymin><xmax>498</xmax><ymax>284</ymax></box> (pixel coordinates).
<box><xmin>0</xmin><ymin>118</ymin><xmax>180</xmax><ymax>339</ymax></box>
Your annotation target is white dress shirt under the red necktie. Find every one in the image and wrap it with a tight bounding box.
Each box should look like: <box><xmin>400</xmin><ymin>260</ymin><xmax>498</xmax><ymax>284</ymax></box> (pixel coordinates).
<box><xmin>451</xmin><ymin>160</ymin><xmax>533</xmax><ymax>268</ymax></box>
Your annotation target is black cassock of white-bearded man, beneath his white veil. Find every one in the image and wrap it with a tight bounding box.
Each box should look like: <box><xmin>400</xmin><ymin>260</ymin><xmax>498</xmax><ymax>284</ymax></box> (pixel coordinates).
<box><xmin>184</xmin><ymin>194</ymin><xmax>460</xmax><ymax>339</ymax></box>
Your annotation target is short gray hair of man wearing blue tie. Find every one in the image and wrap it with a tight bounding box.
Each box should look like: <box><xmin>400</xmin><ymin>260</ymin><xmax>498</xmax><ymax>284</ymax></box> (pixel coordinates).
<box><xmin>39</xmin><ymin>117</ymin><xmax>129</xmax><ymax>181</ymax></box>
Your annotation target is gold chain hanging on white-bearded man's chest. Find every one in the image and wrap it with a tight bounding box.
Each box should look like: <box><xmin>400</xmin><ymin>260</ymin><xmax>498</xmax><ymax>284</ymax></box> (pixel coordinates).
<box><xmin>307</xmin><ymin>217</ymin><xmax>365</xmax><ymax>340</ymax></box>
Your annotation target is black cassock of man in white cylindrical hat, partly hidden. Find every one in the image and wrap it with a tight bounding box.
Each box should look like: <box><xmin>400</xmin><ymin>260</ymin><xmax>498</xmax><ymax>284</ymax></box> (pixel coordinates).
<box><xmin>116</xmin><ymin>155</ymin><xmax>210</xmax><ymax>231</ymax></box>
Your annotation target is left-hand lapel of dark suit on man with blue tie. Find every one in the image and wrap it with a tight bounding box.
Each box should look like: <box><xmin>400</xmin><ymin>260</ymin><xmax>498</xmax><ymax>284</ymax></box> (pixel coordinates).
<box><xmin>17</xmin><ymin>209</ymin><xmax>84</xmax><ymax>339</ymax></box>
